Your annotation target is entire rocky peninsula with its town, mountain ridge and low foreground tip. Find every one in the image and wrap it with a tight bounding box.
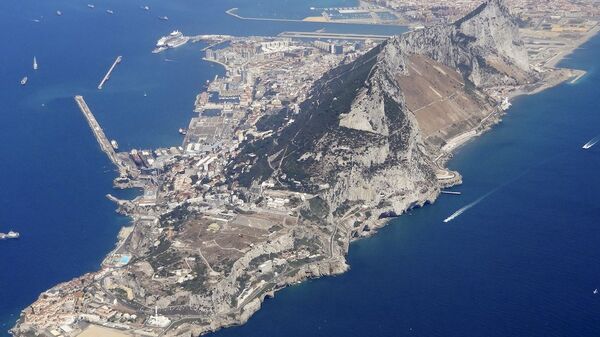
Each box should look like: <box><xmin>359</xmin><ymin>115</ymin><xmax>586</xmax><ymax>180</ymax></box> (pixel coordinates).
<box><xmin>11</xmin><ymin>0</ymin><xmax>596</xmax><ymax>337</ymax></box>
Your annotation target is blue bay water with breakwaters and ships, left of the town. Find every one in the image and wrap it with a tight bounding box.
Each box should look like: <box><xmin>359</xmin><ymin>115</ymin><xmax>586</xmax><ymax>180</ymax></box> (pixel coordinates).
<box><xmin>0</xmin><ymin>0</ymin><xmax>406</xmax><ymax>337</ymax></box>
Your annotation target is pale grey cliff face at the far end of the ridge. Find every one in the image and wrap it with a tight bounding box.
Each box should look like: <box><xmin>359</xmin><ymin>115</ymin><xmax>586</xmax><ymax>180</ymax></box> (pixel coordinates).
<box><xmin>394</xmin><ymin>0</ymin><xmax>530</xmax><ymax>87</ymax></box>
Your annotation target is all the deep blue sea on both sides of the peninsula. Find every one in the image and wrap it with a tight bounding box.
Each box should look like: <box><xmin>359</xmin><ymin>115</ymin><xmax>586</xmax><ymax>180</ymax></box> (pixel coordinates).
<box><xmin>0</xmin><ymin>0</ymin><xmax>600</xmax><ymax>337</ymax></box>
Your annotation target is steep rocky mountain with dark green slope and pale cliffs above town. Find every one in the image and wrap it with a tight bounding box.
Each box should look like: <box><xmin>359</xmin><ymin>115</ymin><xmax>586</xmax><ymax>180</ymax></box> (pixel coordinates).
<box><xmin>229</xmin><ymin>0</ymin><xmax>533</xmax><ymax>220</ymax></box>
